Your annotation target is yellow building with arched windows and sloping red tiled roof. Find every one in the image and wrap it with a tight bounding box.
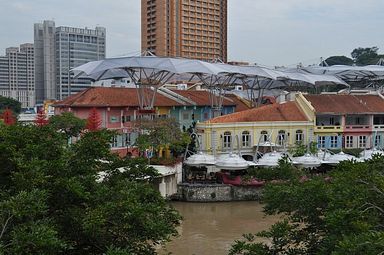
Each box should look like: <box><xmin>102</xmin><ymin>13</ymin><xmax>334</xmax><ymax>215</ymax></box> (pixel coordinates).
<box><xmin>197</xmin><ymin>94</ymin><xmax>314</xmax><ymax>160</ymax></box>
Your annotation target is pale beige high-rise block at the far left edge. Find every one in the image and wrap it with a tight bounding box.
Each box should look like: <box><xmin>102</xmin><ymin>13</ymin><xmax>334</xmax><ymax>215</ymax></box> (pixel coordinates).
<box><xmin>0</xmin><ymin>43</ymin><xmax>35</xmax><ymax>108</ymax></box>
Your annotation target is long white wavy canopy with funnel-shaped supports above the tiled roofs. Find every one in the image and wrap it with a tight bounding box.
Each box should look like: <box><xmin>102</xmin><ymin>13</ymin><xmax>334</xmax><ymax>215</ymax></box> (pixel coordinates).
<box><xmin>72</xmin><ymin>56</ymin><xmax>346</xmax><ymax>111</ymax></box>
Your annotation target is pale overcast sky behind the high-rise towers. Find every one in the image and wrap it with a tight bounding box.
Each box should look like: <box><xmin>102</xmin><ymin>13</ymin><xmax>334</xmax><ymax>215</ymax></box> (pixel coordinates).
<box><xmin>0</xmin><ymin>0</ymin><xmax>384</xmax><ymax>66</ymax></box>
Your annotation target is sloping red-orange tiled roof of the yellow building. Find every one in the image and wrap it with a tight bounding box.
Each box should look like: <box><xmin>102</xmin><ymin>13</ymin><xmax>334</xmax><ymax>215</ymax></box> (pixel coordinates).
<box><xmin>208</xmin><ymin>102</ymin><xmax>308</xmax><ymax>123</ymax></box>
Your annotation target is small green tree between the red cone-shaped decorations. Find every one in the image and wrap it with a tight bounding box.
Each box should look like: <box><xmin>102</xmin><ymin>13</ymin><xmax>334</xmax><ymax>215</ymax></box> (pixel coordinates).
<box><xmin>49</xmin><ymin>112</ymin><xmax>86</xmax><ymax>139</ymax></box>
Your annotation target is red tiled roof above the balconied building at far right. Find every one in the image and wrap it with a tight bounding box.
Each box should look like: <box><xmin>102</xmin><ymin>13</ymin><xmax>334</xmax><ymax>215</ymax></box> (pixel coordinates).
<box><xmin>304</xmin><ymin>94</ymin><xmax>384</xmax><ymax>114</ymax></box>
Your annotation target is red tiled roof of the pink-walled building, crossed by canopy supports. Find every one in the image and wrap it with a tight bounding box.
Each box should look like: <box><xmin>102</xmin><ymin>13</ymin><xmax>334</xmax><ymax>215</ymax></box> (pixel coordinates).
<box><xmin>54</xmin><ymin>87</ymin><xmax>181</xmax><ymax>107</ymax></box>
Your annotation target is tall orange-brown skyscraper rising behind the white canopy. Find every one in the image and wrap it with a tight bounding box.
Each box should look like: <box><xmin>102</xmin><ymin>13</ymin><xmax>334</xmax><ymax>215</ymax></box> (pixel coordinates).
<box><xmin>141</xmin><ymin>0</ymin><xmax>227</xmax><ymax>62</ymax></box>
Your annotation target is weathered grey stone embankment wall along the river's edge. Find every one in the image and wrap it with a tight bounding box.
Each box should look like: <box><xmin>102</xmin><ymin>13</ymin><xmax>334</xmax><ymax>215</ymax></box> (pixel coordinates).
<box><xmin>177</xmin><ymin>183</ymin><xmax>262</xmax><ymax>202</ymax></box>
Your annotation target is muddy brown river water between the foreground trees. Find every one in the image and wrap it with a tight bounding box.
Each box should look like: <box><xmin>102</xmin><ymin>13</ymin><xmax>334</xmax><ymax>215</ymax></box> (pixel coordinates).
<box><xmin>160</xmin><ymin>202</ymin><xmax>278</xmax><ymax>255</ymax></box>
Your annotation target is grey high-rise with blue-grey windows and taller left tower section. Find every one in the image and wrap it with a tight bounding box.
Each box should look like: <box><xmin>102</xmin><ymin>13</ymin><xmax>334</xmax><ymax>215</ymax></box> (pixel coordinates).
<box><xmin>34</xmin><ymin>21</ymin><xmax>106</xmax><ymax>103</ymax></box>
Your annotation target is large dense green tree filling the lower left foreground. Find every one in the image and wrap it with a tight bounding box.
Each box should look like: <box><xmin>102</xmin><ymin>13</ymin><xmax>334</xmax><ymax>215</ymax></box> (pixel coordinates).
<box><xmin>0</xmin><ymin>124</ymin><xmax>180</xmax><ymax>254</ymax></box>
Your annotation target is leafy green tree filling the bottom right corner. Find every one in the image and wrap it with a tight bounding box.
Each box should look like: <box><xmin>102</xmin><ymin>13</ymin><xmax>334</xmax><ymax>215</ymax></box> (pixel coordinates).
<box><xmin>230</xmin><ymin>157</ymin><xmax>384</xmax><ymax>255</ymax></box>
